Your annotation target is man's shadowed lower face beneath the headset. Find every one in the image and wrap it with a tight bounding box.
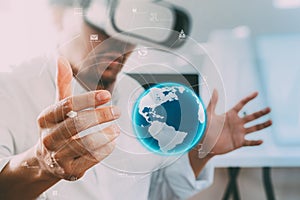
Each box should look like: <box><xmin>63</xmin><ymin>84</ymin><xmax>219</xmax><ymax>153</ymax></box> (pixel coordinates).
<box><xmin>76</xmin><ymin>27</ymin><xmax>134</xmax><ymax>90</ymax></box>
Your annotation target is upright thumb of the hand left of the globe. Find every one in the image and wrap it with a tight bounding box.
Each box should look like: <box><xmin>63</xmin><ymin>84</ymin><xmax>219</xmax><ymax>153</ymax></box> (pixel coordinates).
<box><xmin>56</xmin><ymin>57</ymin><xmax>73</xmax><ymax>101</ymax></box>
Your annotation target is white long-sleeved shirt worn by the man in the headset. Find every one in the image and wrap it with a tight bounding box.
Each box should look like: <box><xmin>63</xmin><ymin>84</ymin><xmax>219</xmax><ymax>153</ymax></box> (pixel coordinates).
<box><xmin>0</xmin><ymin>56</ymin><xmax>213</xmax><ymax>200</ymax></box>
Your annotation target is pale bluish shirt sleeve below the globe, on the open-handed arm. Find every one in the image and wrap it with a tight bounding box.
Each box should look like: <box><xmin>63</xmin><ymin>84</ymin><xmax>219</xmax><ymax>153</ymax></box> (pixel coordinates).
<box><xmin>149</xmin><ymin>155</ymin><xmax>214</xmax><ymax>200</ymax></box>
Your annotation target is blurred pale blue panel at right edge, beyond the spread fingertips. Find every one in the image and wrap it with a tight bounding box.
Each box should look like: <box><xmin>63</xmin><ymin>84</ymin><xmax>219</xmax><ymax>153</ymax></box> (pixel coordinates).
<box><xmin>257</xmin><ymin>34</ymin><xmax>300</xmax><ymax>145</ymax></box>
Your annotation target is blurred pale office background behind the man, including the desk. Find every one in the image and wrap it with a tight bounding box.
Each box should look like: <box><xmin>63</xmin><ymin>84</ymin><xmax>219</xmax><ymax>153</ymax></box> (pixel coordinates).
<box><xmin>0</xmin><ymin>0</ymin><xmax>300</xmax><ymax>200</ymax></box>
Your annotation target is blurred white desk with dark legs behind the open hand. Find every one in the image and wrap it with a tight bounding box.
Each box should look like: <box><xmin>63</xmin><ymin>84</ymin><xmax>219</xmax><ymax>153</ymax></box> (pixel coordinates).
<box><xmin>211</xmin><ymin>130</ymin><xmax>300</xmax><ymax>200</ymax></box>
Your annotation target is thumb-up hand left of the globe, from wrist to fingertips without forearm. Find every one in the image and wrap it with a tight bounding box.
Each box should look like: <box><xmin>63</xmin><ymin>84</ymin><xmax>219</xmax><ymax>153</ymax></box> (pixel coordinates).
<box><xmin>36</xmin><ymin>58</ymin><xmax>120</xmax><ymax>180</ymax></box>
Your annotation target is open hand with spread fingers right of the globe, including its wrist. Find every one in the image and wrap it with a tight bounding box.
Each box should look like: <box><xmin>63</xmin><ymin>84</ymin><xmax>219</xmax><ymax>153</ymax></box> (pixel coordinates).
<box><xmin>189</xmin><ymin>90</ymin><xmax>272</xmax><ymax>177</ymax></box>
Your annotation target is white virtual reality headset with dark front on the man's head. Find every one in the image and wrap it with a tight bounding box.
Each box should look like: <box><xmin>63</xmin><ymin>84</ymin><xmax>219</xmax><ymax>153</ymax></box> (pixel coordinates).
<box><xmin>84</xmin><ymin>0</ymin><xmax>191</xmax><ymax>49</ymax></box>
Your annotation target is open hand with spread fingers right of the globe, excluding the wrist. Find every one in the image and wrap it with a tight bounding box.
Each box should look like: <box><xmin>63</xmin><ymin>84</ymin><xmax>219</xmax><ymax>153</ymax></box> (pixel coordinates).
<box><xmin>206</xmin><ymin>90</ymin><xmax>272</xmax><ymax>155</ymax></box>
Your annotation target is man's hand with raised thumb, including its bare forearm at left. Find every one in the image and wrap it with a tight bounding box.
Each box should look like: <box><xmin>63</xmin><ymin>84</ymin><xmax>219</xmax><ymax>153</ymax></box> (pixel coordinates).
<box><xmin>0</xmin><ymin>58</ymin><xmax>120</xmax><ymax>199</ymax></box>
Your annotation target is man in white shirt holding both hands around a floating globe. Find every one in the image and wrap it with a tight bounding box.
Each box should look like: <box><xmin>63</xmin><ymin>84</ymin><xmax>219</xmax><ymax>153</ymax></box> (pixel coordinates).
<box><xmin>0</xmin><ymin>0</ymin><xmax>271</xmax><ymax>199</ymax></box>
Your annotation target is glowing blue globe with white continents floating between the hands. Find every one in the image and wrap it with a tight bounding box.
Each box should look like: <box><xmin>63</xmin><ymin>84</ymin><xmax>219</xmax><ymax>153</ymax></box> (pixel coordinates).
<box><xmin>132</xmin><ymin>83</ymin><xmax>207</xmax><ymax>155</ymax></box>
